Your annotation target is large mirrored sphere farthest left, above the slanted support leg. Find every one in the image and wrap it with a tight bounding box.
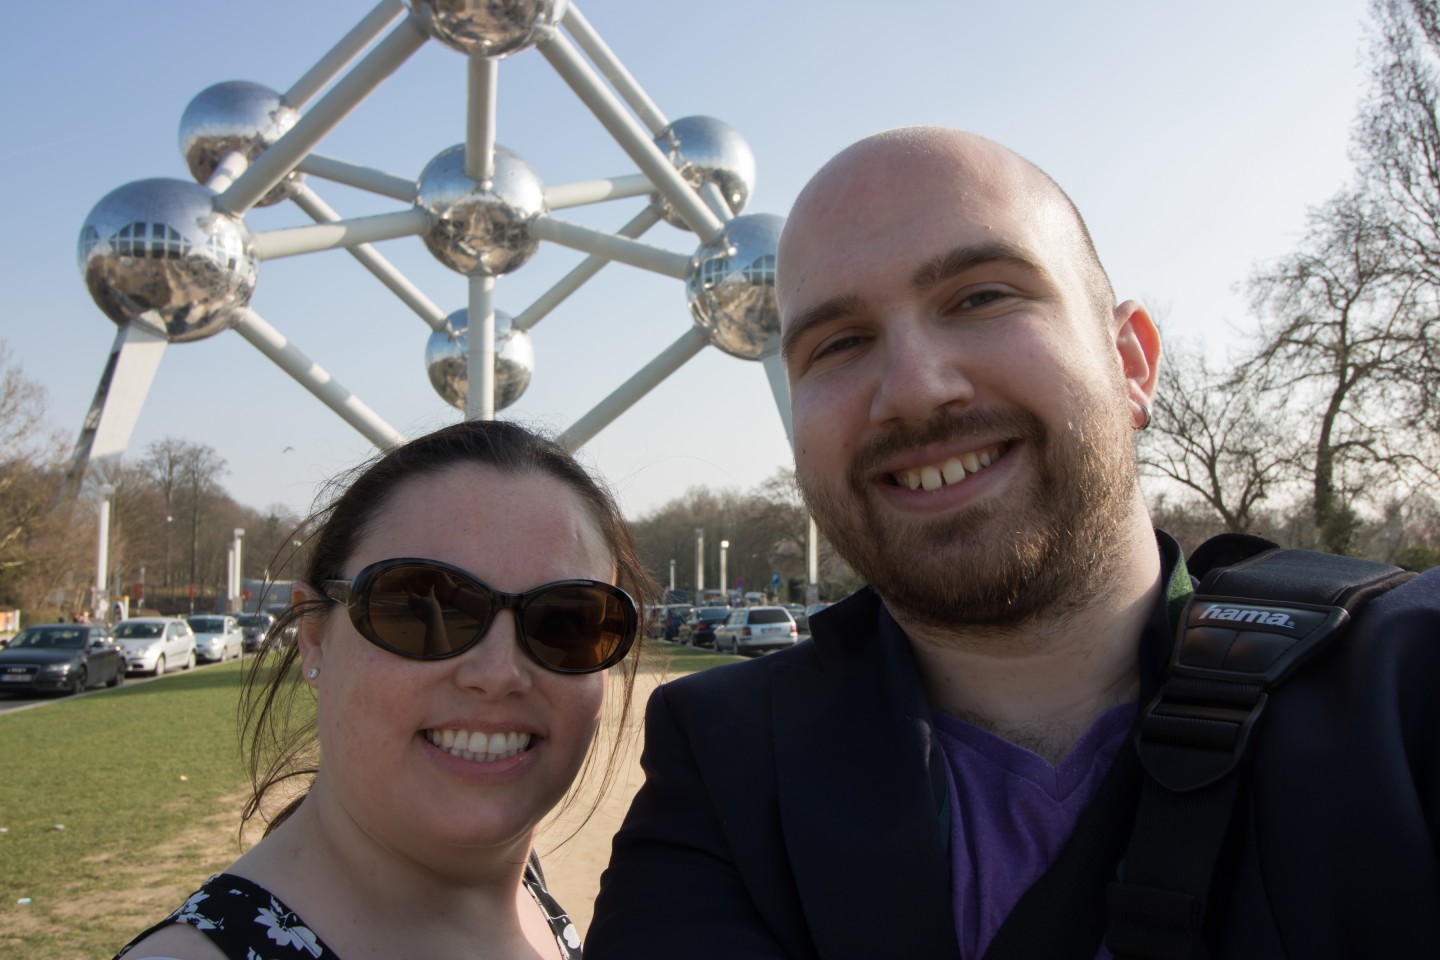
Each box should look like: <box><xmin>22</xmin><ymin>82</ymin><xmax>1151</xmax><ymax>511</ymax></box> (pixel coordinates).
<box><xmin>78</xmin><ymin>180</ymin><xmax>256</xmax><ymax>343</ymax></box>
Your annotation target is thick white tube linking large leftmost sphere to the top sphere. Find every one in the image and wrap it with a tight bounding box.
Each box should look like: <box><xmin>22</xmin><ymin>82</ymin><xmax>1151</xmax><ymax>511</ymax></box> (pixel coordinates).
<box><xmin>216</xmin><ymin>17</ymin><xmax>426</xmax><ymax>216</ymax></box>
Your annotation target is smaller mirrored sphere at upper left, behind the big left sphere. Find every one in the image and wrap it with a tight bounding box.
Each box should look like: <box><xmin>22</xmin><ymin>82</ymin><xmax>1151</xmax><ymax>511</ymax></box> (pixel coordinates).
<box><xmin>180</xmin><ymin>81</ymin><xmax>302</xmax><ymax>207</ymax></box>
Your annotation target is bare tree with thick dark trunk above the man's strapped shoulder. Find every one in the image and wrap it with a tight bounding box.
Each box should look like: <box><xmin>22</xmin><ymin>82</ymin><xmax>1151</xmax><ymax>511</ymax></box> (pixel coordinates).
<box><xmin>1243</xmin><ymin>191</ymin><xmax>1440</xmax><ymax>553</ymax></box>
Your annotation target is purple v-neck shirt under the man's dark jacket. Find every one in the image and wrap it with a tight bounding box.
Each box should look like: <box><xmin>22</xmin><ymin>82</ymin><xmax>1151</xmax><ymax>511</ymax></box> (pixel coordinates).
<box><xmin>935</xmin><ymin>704</ymin><xmax>1138</xmax><ymax>960</ymax></box>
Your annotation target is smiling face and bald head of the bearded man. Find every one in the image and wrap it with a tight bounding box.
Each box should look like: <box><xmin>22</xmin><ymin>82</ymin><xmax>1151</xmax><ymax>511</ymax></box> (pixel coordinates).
<box><xmin>778</xmin><ymin>131</ymin><xmax>1148</xmax><ymax>628</ymax></box>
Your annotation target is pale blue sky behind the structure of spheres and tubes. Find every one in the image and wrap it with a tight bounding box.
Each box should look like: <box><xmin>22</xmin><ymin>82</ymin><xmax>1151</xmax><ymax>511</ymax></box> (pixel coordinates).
<box><xmin>0</xmin><ymin>0</ymin><xmax>1365</xmax><ymax>517</ymax></box>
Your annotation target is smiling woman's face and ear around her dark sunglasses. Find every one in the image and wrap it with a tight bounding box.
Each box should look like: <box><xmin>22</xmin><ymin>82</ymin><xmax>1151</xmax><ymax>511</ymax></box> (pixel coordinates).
<box><xmin>300</xmin><ymin>465</ymin><xmax>615</xmax><ymax>855</ymax></box>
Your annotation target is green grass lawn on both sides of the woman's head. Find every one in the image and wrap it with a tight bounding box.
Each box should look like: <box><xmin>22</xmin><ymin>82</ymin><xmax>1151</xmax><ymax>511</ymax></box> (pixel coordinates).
<box><xmin>0</xmin><ymin>642</ymin><xmax>739</xmax><ymax>960</ymax></box>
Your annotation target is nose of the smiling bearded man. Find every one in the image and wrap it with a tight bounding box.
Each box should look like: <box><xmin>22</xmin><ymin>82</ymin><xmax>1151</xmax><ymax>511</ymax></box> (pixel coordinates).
<box><xmin>870</xmin><ymin>320</ymin><xmax>975</xmax><ymax>423</ymax></box>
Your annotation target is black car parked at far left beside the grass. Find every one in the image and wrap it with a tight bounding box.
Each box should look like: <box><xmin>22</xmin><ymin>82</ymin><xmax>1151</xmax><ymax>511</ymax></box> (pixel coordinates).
<box><xmin>0</xmin><ymin>623</ymin><xmax>125</xmax><ymax>694</ymax></box>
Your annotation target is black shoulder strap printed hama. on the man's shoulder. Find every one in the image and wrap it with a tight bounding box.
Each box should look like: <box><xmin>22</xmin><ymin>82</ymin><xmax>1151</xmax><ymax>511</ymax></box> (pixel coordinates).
<box><xmin>1106</xmin><ymin>537</ymin><xmax>1414</xmax><ymax>960</ymax></box>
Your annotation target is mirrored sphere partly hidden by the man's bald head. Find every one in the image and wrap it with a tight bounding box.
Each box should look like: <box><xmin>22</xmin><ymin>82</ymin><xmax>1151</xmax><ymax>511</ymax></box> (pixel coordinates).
<box><xmin>685</xmin><ymin>213</ymin><xmax>785</xmax><ymax>360</ymax></box>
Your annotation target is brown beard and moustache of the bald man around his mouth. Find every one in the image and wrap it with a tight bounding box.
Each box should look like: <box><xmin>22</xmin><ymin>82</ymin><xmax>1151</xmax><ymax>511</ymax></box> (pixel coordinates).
<box><xmin>798</xmin><ymin>404</ymin><xmax>1136</xmax><ymax>630</ymax></box>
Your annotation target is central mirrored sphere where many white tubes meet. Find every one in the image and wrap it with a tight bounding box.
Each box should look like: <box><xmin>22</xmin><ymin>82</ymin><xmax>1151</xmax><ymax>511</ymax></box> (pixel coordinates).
<box><xmin>415</xmin><ymin>144</ymin><xmax>546</xmax><ymax>276</ymax></box>
